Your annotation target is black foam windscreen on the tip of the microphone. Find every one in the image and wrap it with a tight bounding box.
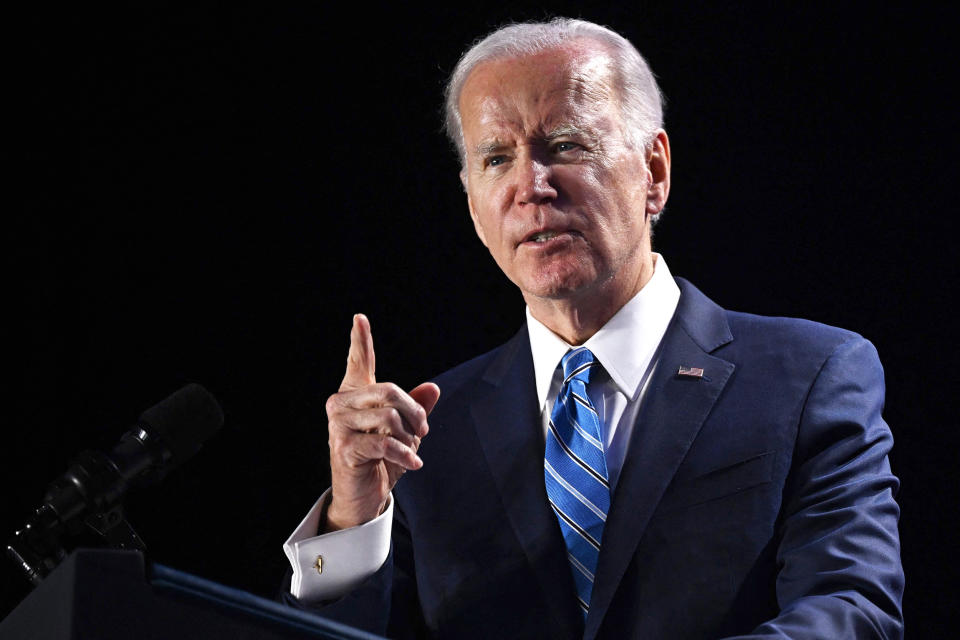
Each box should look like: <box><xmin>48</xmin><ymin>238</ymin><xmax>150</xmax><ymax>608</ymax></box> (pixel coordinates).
<box><xmin>140</xmin><ymin>383</ymin><xmax>223</xmax><ymax>465</ymax></box>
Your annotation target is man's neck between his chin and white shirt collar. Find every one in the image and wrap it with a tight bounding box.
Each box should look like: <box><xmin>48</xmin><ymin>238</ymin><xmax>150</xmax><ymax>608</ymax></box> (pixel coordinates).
<box><xmin>524</xmin><ymin>253</ymin><xmax>656</xmax><ymax>346</ymax></box>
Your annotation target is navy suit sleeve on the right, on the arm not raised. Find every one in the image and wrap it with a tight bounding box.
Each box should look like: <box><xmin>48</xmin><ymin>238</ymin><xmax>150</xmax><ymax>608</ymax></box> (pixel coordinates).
<box><xmin>724</xmin><ymin>338</ymin><xmax>904</xmax><ymax>639</ymax></box>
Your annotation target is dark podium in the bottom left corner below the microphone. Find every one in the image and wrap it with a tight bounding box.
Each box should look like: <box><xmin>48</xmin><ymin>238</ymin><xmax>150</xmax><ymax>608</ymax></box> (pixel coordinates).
<box><xmin>0</xmin><ymin>549</ymin><xmax>382</xmax><ymax>640</ymax></box>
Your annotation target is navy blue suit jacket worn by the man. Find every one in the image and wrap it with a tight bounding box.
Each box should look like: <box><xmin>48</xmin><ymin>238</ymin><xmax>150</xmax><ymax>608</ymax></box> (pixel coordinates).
<box><xmin>291</xmin><ymin>280</ymin><xmax>903</xmax><ymax>640</ymax></box>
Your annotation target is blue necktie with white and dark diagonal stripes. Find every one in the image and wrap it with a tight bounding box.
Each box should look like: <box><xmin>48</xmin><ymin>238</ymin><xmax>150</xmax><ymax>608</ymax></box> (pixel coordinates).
<box><xmin>543</xmin><ymin>347</ymin><xmax>610</xmax><ymax>617</ymax></box>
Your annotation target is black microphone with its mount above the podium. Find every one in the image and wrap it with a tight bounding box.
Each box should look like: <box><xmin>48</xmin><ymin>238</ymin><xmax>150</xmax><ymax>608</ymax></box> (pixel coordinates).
<box><xmin>7</xmin><ymin>384</ymin><xmax>223</xmax><ymax>585</ymax></box>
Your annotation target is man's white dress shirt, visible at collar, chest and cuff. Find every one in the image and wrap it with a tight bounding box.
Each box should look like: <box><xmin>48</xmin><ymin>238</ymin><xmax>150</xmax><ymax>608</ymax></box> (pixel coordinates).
<box><xmin>283</xmin><ymin>254</ymin><xmax>680</xmax><ymax>602</ymax></box>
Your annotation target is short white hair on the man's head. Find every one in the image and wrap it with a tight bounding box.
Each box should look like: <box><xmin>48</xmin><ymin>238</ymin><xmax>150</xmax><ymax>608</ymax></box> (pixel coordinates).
<box><xmin>444</xmin><ymin>18</ymin><xmax>663</xmax><ymax>166</ymax></box>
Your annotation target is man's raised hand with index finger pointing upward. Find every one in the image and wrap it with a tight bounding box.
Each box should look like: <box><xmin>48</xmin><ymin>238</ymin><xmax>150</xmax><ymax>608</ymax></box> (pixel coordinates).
<box><xmin>323</xmin><ymin>314</ymin><xmax>440</xmax><ymax>531</ymax></box>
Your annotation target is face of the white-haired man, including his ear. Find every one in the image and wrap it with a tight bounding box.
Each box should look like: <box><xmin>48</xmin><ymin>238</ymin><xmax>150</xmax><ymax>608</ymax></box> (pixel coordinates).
<box><xmin>460</xmin><ymin>44</ymin><xmax>669</xmax><ymax>305</ymax></box>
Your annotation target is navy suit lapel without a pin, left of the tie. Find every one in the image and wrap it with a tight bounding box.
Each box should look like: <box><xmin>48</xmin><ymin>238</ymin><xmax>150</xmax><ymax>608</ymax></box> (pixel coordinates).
<box><xmin>470</xmin><ymin>327</ymin><xmax>583</xmax><ymax>638</ymax></box>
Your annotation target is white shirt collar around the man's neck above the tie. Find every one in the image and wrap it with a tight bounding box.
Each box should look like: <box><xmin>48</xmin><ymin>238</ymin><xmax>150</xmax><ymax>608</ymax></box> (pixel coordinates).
<box><xmin>527</xmin><ymin>253</ymin><xmax>680</xmax><ymax>410</ymax></box>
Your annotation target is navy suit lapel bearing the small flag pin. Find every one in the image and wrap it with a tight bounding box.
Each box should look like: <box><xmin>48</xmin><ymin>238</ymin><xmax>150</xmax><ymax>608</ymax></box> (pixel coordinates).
<box><xmin>584</xmin><ymin>279</ymin><xmax>734</xmax><ymax>639</ymax></box>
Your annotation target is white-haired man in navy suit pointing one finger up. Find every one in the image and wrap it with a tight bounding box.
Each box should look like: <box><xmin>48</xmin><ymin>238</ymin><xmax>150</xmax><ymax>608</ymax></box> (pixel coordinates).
<box><xmin>285</xmin><ymin>20</ymin><xmax>903</xmax><ymax>638</ymax></box>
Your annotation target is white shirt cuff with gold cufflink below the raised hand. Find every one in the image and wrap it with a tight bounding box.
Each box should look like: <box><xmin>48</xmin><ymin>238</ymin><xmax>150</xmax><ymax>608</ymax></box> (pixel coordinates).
<box><xmin>283</xmin><ymin>489</ymin><xmax>393</xmax><ymax>602</ymax></box>
